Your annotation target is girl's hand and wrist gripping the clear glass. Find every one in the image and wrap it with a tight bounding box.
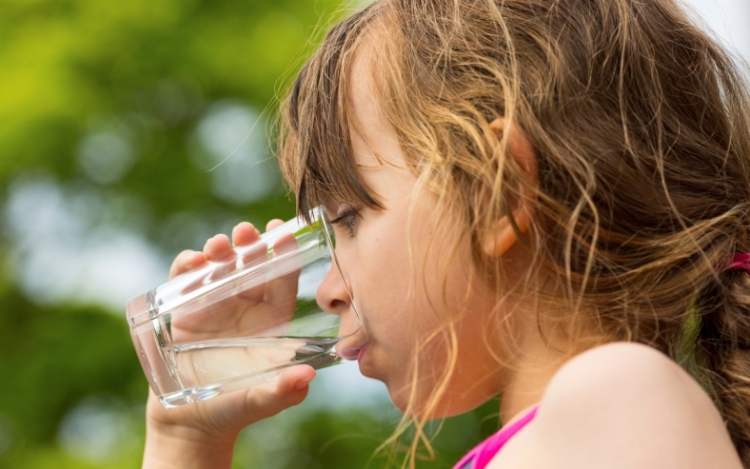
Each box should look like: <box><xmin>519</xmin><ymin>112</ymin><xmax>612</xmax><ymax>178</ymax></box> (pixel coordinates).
<box><xmin>144</xmin><ymin>220</ymin><xmax>315</xmax><ymax>468</ymax></box>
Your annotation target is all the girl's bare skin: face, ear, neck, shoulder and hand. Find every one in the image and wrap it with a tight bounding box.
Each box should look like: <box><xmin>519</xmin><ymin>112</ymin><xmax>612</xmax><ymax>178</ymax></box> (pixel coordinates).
<box><xmin>143</xmin><ymin>38</ymin><xmax>742</xmax><ymax>469</ymax></box>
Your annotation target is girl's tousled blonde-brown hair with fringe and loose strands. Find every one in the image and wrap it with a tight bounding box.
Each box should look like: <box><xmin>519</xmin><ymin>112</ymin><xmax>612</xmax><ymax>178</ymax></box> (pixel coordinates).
<box><xmin>278</xmin><ymin>0</ymin><xmax>750</xmax><ymax>468</ymax></box>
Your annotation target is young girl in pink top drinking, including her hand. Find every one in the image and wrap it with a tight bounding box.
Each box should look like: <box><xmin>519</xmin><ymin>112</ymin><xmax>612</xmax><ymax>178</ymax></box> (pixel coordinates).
<box><xmin>144</xmin><ymin>0</ymin><xmax>750</xmax><ymax>469</ymax></box>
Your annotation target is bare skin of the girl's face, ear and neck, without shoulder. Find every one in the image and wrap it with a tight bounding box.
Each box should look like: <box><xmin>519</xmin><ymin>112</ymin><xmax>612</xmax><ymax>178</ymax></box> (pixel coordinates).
<box><xmin>318</xmin><ymin>37</ymin><xmax>571</xmax><ymax>421</ymax></box>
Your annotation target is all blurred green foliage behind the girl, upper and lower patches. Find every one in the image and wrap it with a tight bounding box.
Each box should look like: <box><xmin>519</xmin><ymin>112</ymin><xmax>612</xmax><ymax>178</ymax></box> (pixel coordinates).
<box><xmin>0</xmin><ymin>0</ymin><xmax>506</xmax><ymax>469</ymax></box>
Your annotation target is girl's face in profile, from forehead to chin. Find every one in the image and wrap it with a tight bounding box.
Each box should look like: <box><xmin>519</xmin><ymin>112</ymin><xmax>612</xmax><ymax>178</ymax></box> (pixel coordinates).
<box><xmin>318</xmin><ymin>52</ymin><xmax>508</xmax><ymax>417</ymax></box>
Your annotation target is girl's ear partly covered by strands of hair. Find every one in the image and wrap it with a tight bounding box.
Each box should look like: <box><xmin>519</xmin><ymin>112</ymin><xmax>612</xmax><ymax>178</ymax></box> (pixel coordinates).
<box><xmin>482</xmin><ymin>117</ymin><xmax>539</xmax><ymax>257</ymax></box>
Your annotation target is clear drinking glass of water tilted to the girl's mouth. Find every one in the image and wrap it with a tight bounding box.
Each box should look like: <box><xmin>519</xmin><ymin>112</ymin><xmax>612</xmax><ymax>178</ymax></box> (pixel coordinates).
<box><xmin>126</xmin><ymin>208</ymin><xmax>361</xmax><ymax>407</ymax></box>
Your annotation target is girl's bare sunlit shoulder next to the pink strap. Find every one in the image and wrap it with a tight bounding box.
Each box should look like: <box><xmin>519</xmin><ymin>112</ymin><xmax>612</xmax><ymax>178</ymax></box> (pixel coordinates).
<box><xmin>534</xmin><ymin>343</ymin><xmax>742</xmax><ymax>469</ymax></box>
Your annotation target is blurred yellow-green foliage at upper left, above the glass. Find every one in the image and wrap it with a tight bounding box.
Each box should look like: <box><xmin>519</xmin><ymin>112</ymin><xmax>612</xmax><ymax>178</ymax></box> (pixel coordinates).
<box><xmin>0</xmin><ymin>0</ymin><xmax>350</xmax><ymax>230</ymax></box>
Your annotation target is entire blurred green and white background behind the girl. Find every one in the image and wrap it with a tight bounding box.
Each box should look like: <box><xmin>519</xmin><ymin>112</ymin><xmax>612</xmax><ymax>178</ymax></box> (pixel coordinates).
<box><xmin>0</xmin><ymin>0</ymin><xmax>750</xmax><ymax>469</ymax></box>
